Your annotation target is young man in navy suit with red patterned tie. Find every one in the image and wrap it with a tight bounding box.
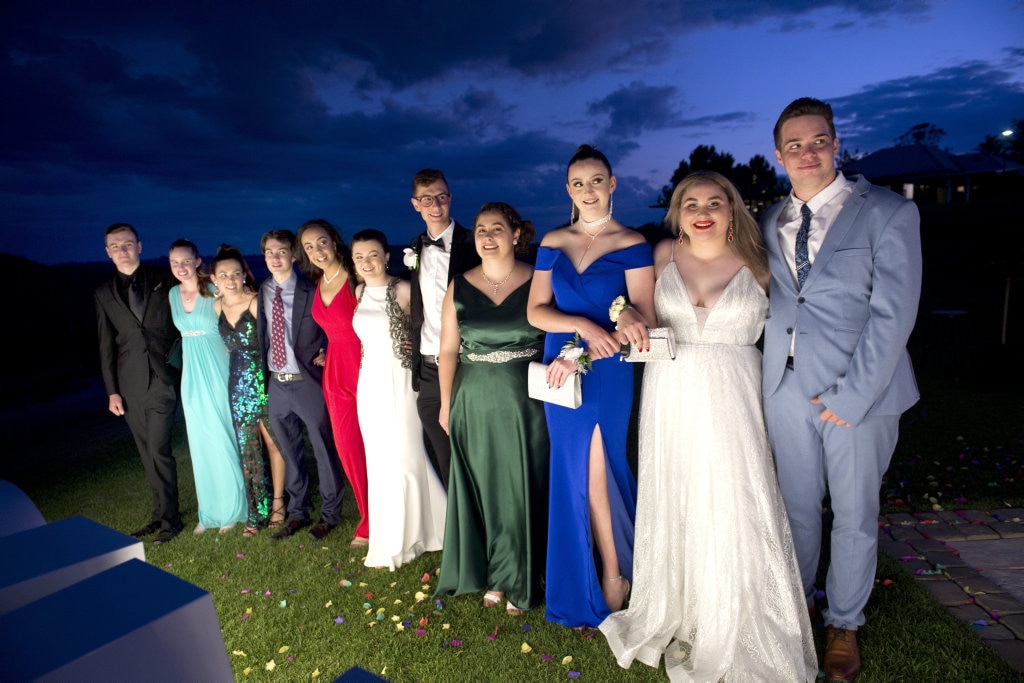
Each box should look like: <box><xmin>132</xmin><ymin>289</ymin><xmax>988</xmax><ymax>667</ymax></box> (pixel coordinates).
<box><xmin>257</xmin><ymin>230</ymin><xmax>345</xmax><ymax>541</ymax></box>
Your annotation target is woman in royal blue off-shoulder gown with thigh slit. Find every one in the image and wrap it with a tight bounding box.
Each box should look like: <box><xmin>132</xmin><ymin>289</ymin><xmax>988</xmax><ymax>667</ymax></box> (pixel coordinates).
<box><xmin>528</xmin><ymin>144</ymin><xmax>654</xmax><ymax>628</ymax></box>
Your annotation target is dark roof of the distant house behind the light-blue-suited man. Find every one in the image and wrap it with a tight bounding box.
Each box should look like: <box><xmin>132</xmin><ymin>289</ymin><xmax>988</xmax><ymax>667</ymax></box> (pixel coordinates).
<box><xmin>843</xmin><ymin>144</ymin><xmax>1024</xmax><ymax>182</ymax></box>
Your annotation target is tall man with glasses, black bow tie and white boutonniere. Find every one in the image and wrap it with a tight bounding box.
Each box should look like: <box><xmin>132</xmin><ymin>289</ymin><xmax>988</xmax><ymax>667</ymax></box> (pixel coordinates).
<box><xmin>407</xmin><ymin>169</ymin><xmax>480</xmax><ymax>490</ymax></box>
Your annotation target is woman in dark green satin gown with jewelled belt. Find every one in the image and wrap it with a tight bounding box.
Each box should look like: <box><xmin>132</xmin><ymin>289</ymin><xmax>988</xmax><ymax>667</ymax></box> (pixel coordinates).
<box><xmin>437</xmin><ymin>202</ymin><xmax>548</xmax><ymax>614</ymax></box>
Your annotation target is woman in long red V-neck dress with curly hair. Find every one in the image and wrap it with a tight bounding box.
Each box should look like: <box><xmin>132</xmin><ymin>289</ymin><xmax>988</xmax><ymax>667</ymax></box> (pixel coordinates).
<box><xmin>296</xmin><ymin>218</ymin><xmax>370</xmax><ymax>548</ymax></box>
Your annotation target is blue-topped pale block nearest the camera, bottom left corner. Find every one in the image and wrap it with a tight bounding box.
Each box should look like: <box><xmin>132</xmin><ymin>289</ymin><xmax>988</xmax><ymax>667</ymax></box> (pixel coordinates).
<box><xmin>0</xmin><ymin>560</ymin><xmax>233</xmax><ymax>681</ymax></box>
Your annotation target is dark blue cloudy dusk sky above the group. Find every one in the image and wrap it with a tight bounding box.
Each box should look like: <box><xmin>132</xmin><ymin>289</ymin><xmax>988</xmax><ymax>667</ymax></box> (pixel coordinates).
<box><xmin>0</xmin><ymin>0</ymin><xmax>1024</xmax><ymax>263</ymax></box>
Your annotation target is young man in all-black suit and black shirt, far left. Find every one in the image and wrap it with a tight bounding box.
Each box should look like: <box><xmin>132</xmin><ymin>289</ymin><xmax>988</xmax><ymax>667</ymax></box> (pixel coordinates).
<box><xmin>93</xmin><ymin>223</ymin><xmax>181</xmax><ymax>544</ymax></box>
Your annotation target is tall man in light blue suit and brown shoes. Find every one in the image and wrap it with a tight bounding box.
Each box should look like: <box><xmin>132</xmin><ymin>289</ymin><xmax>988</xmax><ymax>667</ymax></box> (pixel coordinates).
<box><xmin>762</xmin><ymin>97</ymin><xmax>922</xmax><ymax>681</ymax></box>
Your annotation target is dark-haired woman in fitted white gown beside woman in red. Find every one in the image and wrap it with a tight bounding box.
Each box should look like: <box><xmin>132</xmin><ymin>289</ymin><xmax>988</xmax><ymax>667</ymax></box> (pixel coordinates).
<box><xmin>352</xmin><ymin>230</ymin><xmax>447</xmax><ymax>571</ymax></box>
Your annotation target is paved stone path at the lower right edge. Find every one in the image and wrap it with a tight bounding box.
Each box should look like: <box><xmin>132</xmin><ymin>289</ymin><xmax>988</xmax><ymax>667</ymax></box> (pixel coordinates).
<box><xmin>879</xmin><ymin>508</ymin><xmax>1024</xmax><ymax>673</ymax></box>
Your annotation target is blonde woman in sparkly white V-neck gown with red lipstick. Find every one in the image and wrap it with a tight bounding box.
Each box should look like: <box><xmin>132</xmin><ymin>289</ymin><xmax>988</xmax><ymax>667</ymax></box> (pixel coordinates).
<box><xmin>600</xmin><ymin>173</ymin><xmax>817</xmax><ymax>681</ymax></box>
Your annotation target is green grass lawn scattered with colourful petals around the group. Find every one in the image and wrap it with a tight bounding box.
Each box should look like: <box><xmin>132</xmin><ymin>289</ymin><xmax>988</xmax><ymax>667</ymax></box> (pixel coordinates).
<box><xmin>7</xmin><ymin>376</ymin><xmax>1024</xmax><ymax>683</ymax></box>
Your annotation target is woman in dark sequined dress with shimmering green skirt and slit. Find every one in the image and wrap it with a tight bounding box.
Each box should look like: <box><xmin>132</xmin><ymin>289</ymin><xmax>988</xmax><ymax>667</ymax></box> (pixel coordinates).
<box><xmin>212</xmin><ymin>245</ymin><xmax>285</xmax><ymax>537</ymax></box>
